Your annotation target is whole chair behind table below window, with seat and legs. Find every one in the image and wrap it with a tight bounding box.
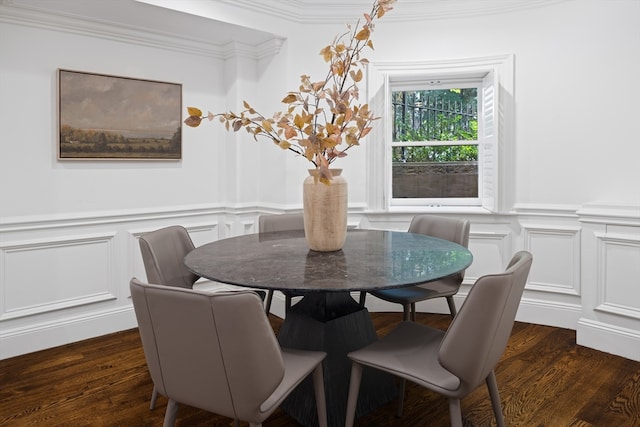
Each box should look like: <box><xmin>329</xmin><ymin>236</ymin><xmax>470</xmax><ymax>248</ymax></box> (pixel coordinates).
<box><xmin>360</xmin><ymin>214</ymin><xmax>470</xmax><ymax>321</ymax></box>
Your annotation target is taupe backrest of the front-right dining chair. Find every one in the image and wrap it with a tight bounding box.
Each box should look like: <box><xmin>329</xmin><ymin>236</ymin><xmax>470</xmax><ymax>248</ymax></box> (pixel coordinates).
<box><xmin>438</xmin><ymin>251</ymin><xmax>533</xmax><ymax>394</ymax></box>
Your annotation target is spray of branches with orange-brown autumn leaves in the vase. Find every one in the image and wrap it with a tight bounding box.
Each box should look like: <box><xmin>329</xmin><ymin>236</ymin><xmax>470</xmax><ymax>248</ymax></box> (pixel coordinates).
<box><xmin>181</xmin><ymin>0</ymin><xmax>396</xmax><ymax>184</ymax></box>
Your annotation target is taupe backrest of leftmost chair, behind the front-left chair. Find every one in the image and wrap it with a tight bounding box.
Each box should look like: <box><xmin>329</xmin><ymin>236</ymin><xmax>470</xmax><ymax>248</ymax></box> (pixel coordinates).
<box><xmin>139</xmin><ymin>225</ymin><xmax>199</xmax><ymax>288</ymax></box>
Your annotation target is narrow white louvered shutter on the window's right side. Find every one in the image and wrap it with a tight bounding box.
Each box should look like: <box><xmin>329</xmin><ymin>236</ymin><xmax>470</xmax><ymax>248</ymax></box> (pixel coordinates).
<box><xmin>478</xmin><ymin>71</ymin><xmax>500</xmax><ymax>212</ymax></box>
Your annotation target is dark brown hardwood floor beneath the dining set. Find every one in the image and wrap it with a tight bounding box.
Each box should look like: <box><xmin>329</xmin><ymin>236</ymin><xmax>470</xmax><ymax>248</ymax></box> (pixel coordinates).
<box><xmin>0</xmin><ymin>313</ymin><xmax>640</xmax><ymax>427</ymax></box>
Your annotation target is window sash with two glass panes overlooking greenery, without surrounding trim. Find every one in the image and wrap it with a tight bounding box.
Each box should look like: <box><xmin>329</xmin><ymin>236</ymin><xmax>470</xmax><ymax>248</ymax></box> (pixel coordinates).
<box><xmin>391</xmin><ymin>84</ymin><xmax>480</xmax><ymax>205</ymax></box>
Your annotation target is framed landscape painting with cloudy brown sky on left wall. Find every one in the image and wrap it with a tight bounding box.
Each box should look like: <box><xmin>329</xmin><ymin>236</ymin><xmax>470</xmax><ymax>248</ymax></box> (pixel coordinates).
<box><xmin>58</xmin><ymin>69</ymin><xmax>182</xmax><ymax>160</ymax></box>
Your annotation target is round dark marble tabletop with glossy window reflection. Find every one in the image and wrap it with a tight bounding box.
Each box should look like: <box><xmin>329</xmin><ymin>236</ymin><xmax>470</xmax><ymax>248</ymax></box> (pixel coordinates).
<box><xmin>185</xmin><ymin>229</ymin><xmax>473</xmax><ymax>292</ymax></box>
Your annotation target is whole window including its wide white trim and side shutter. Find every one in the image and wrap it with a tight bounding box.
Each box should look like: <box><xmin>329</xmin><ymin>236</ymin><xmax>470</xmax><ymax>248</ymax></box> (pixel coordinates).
<box><xmin>368</xmin><ymin>55</ymin><xmax>513</xmax><ymax>212</ymax></box>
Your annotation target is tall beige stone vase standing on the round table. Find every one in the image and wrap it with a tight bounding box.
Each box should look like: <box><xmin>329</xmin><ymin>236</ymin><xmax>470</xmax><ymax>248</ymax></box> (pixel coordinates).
<box><xmin>302</xmin><ymin>169</ymin><xmax>348</xmax><ymax>252</ymax></box>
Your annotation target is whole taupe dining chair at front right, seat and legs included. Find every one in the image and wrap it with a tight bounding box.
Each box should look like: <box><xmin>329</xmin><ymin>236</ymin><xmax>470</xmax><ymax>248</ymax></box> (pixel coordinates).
<box><xmin>345</xmin><ymin>251</ymin><xmax>533</xmax><ymax>427</ymax></box>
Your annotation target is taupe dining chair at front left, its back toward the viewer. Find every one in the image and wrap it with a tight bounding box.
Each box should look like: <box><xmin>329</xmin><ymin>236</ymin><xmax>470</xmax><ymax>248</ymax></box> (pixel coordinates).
<box><xmin>130</xmin><ymin>278</ymin><xmax>327</xmax><ymax>427</ymax></box>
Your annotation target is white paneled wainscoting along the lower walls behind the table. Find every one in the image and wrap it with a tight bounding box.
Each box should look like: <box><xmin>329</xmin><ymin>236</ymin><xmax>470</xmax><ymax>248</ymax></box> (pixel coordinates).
<box><xmin>0</xmin><ymin>203</ymin><xmax>640</xmax><ymax>357</ymax></box>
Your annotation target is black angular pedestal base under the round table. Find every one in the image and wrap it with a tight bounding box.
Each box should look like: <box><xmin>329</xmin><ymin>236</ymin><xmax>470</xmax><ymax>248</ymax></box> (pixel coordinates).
<box><xmin>278</xmin><ymin>292</ymin><xmax>398</xmax><ymax>427</ymax></box>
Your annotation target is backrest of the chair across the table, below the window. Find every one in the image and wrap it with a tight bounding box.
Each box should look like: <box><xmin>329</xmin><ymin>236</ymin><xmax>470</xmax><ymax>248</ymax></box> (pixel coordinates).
<box><xmin>408</xmin><ymin>214</ymin><xmax>471</xmax><ymax>284</ymax></box>
